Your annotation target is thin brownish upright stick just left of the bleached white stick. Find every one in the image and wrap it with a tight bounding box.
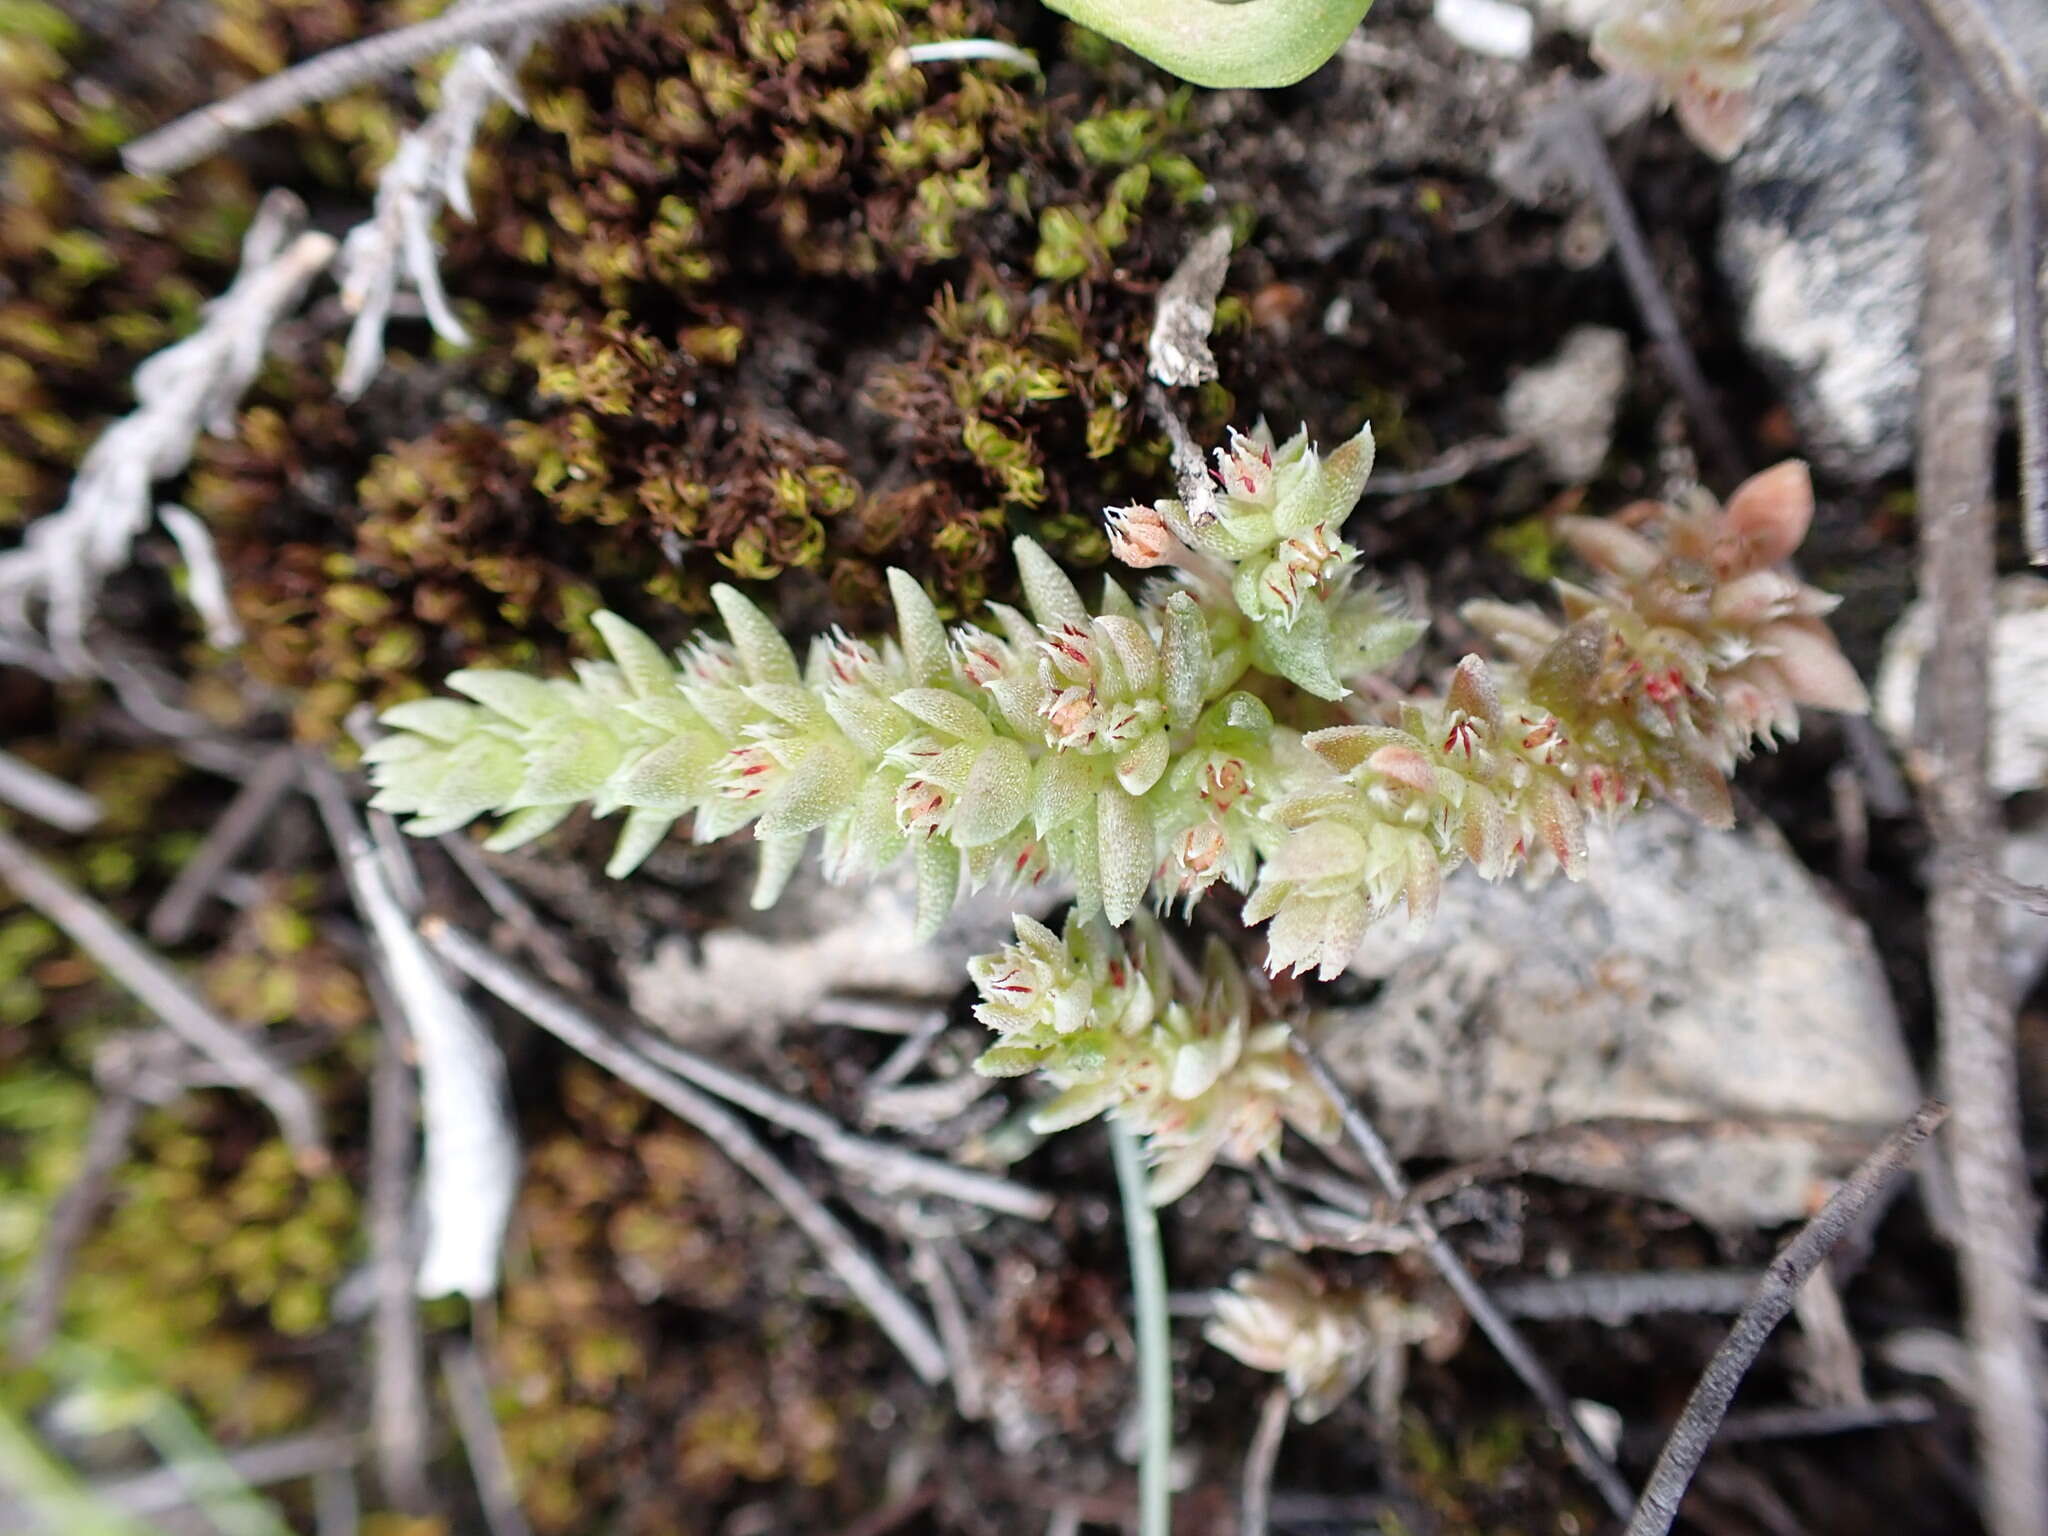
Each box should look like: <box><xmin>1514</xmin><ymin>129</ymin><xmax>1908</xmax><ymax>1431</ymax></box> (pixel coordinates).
<box><xmin>365</xmin><ymin>967</ymin><xmax>432</xmax><ymax>1516</ymax></box>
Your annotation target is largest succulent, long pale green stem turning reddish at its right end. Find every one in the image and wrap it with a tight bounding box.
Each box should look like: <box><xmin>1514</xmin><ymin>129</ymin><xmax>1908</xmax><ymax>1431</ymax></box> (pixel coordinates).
<box><xmin>371</xmin><ymin>434</ymin><xmax>1864</xmax><ymax>977</ymax></box>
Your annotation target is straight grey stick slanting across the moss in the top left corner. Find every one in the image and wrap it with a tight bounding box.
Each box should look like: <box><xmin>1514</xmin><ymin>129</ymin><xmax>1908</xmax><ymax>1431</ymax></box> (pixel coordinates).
<box><xmin>121</xmin><ymin>0</ymin><xmax>641</xmax><ymax>176</ymax></box>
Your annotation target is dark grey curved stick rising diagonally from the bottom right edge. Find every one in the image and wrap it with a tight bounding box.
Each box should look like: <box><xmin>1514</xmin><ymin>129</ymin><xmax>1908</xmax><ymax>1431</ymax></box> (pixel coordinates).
<box><xmin>1626</xmin><ymin>1100</ymin><xmax>1948</xmax><ymax>1536</ymax></box>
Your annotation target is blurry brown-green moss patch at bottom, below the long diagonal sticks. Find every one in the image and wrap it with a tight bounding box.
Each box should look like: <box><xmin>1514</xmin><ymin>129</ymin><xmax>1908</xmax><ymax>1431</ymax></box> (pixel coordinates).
<box><xmin>498</xmin><ymin>1063</ymin><xmax>866</xmax><ymax>1532</ymax></box>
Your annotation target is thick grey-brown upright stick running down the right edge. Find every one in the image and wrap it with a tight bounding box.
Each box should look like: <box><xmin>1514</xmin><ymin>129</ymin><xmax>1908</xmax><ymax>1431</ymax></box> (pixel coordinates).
<box><xmin>1913</xmin><ymin>92</ymin><xmax>2048</xmax><ymax>1536</ymax></box>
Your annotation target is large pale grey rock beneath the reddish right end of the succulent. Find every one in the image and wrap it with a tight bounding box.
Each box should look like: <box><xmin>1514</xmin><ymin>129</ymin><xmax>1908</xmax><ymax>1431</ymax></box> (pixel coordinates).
<box><xmin>1325</xmin><ymin>811</ymin><xmax>1917</xmax><ymax>1227</ymax></box>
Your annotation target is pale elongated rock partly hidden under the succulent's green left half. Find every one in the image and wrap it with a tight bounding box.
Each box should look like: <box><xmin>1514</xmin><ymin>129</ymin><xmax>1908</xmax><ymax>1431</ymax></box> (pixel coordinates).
<box><xmin>625</xmin><ymin>866</ymin><xmax>1040</xmax><ymax>1044</ymax></box>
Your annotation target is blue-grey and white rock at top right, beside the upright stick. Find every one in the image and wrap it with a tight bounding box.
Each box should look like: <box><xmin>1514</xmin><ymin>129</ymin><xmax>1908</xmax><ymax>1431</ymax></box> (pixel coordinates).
<box><xmin>1720</xmin><ymin>0</ymin><xmax>2048</xmax><ymax>479</ymax></box>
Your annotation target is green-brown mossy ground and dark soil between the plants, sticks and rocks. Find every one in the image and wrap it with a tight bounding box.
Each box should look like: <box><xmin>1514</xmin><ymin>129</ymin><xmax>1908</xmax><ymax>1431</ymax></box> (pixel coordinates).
<box><xmin>0</xmin><ymin>0</ymin><xmax>1946</xmax><ymax>1536</ymax></box>
